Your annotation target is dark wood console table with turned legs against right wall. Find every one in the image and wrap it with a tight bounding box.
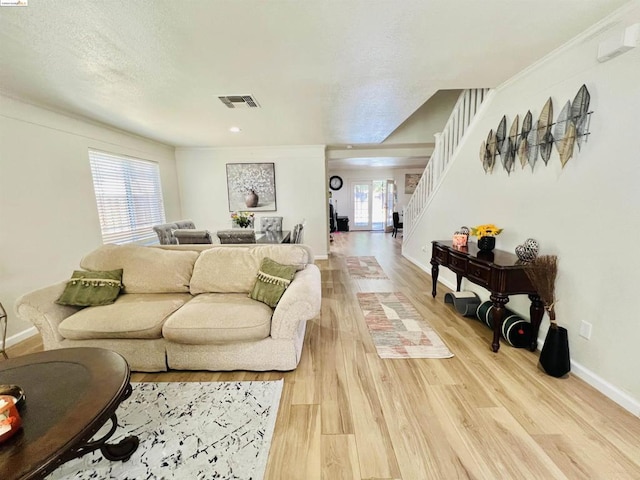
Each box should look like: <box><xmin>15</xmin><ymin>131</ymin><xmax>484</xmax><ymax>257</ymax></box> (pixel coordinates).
<box><xmin>431</xmin><ymin>240</ymin><xmax>544</xmax><ymax>352</ymax></box>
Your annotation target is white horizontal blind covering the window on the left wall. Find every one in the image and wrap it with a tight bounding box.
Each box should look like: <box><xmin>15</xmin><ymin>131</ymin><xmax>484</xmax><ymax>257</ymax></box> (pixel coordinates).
<box><xmin>89</xmin><ymin>150</ymin><xmax>165</xmax><ymax>244</ymax></box>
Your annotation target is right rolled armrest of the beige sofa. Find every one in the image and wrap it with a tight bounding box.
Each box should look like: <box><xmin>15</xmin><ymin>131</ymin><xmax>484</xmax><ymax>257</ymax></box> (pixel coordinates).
<box><xmin>271</xmin><ymin>264</ymin><xmax>322</xmax><ymax>339</ymax></box>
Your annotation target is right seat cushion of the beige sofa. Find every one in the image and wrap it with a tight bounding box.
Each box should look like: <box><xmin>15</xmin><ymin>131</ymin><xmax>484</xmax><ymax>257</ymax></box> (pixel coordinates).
<box><xmin>162</xmin><ymin>293</ymin><xmax>272</xmax><ymax>345</ymax></box>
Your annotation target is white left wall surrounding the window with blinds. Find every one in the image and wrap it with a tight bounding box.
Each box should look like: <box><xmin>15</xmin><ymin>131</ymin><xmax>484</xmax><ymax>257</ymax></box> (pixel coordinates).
<box><xmin>0</xmin><ymin>96</ymin><xmax>181</xmax><ymax>343</ymax></box>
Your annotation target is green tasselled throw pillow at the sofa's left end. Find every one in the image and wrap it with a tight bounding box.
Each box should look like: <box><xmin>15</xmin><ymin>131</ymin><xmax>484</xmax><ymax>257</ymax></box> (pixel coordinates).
<box><xmin>56</xmin><ymin>269</ymin><xmax>122</xmax><ymax>307</ymax></box>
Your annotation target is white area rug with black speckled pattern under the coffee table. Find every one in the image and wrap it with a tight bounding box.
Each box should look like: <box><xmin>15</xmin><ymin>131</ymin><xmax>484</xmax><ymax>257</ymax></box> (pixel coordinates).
<box><xmin>47</xmin><ymin>380</ymin><xmax>283</xmax><ymax>480</ymax></box>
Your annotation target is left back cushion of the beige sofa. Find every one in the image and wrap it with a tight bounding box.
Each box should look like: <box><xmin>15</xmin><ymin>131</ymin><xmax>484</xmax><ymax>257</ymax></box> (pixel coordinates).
<box><xmin>80</xmin><ymin>245</ymin><xmax>199</xmax><ymax>293</ymax></box>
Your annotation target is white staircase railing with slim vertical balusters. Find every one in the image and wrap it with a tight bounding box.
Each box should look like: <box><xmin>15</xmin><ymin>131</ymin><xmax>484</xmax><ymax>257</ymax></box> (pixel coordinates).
<box><xmin>403</xmin><ymin>88</ymin><xmax>489</xmax><ymax>242</ymax></box>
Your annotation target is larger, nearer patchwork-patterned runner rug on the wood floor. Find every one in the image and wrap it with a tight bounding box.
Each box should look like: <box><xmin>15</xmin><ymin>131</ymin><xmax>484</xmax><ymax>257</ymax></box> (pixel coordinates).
<box><xmin>357</xmin><ymin>292</ymin><xmax>453</xmax><ymax>358</ymax></box>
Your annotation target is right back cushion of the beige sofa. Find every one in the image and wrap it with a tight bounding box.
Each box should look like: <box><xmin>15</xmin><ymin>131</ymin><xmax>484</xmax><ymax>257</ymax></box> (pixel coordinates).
<box><xmin>191</xmin><ymin>244</ymin><xmax>313</xmax><ymax>295</ymax></box>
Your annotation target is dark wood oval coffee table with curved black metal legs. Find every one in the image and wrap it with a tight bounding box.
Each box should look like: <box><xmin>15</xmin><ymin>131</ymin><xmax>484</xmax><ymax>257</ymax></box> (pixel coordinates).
<box><xmin>0</xmin><ymin>348</ymin><xmax>138</xmax><ymax>480</ymax></box>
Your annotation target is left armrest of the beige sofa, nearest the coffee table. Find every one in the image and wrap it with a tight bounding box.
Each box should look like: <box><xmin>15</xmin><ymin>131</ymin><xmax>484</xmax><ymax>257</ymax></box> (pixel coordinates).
<box><xmin>15</xmin><ymin>281</ymin><xmax>81</xmax><ymax>350</ymax></box>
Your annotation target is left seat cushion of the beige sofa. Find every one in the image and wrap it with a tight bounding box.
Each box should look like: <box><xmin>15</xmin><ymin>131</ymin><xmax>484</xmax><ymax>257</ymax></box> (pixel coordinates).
<box><xmin>58</xmin><ymin>293</ymin><xmax>192</xmax><ymax>340</ymax></box>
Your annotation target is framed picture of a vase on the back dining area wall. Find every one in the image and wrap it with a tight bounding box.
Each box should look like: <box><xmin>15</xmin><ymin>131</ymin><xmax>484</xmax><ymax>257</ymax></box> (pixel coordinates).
<box><xmin>227</xmin><ymin>163</ymin><xmax>277</xmax><ymax>212</ymax></box>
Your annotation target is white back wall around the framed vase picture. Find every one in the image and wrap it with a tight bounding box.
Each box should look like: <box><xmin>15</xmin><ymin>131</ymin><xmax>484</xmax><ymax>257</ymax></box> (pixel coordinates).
<box><xmin>176</xmin><ymin>145</ymin><xmax>329</xmax><ymax>258</ymax></box>
